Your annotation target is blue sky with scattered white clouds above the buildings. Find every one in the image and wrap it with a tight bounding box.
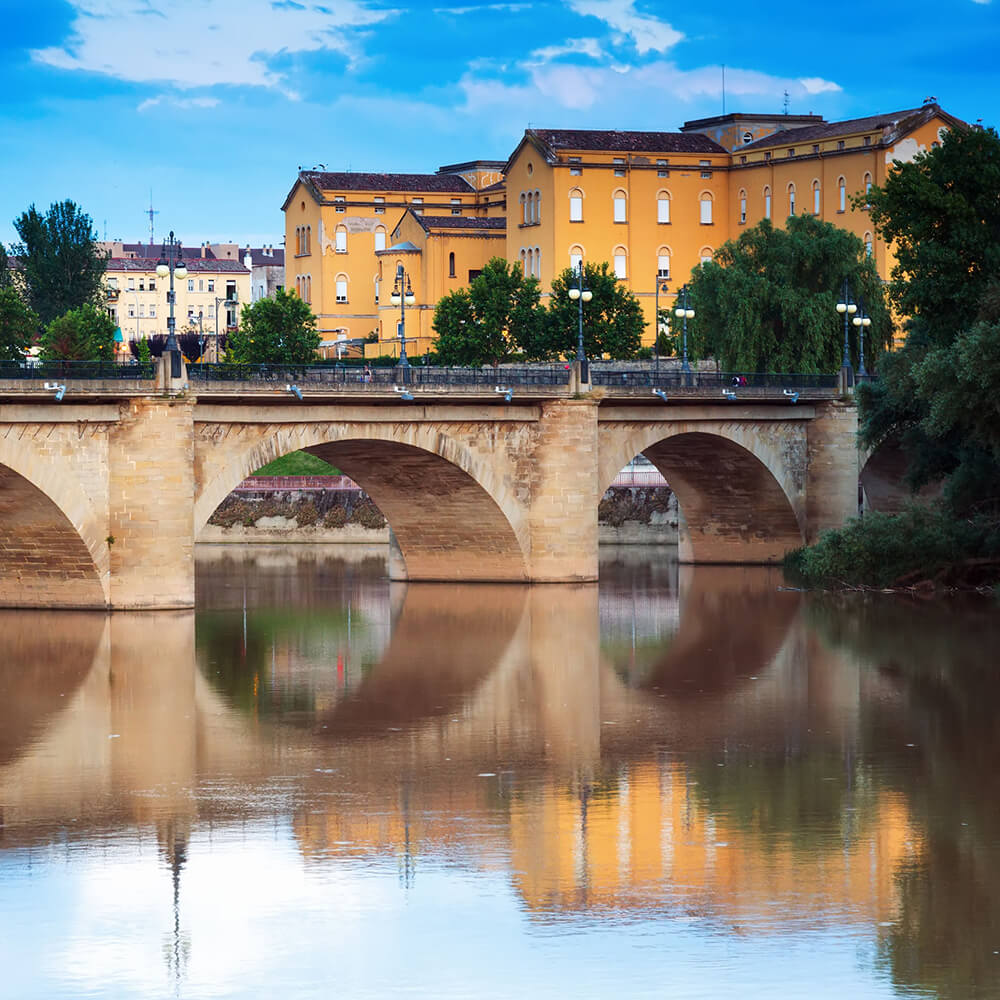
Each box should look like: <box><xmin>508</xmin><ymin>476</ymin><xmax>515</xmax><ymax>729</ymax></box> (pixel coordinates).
<box><xmin>0</xmin><ymin>0</ymin><xmax>1000</xmax><ymax>244</ymax></box>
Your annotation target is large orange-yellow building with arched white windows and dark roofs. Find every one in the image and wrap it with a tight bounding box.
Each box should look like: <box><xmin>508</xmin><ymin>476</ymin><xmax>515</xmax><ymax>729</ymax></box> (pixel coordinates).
<box><xmin>283</xmin><ymin>100</ymin><xmax>962</xmax><ymax>356</ymax></box>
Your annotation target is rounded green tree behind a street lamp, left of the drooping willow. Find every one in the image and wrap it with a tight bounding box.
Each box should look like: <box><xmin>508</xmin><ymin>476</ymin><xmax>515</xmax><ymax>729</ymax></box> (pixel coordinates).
<box><xmin>545</xmin><ymin>261</ymin><xmax>646</xmax><ymax>360</ymax></box>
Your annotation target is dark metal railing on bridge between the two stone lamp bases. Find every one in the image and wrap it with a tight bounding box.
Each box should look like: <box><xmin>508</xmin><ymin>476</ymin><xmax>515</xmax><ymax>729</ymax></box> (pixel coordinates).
<box><xmin>188</xmin><ymin>364</ymin><xmax>570</xmax><ymax>388</ymax></box>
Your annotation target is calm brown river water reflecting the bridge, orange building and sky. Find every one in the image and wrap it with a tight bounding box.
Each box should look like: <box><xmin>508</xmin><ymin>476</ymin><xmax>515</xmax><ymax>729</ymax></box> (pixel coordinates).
<box><xmin>0</xmin><ymin>546</ymin><xmax>1000</xmax><ymax>1000</ymax></box>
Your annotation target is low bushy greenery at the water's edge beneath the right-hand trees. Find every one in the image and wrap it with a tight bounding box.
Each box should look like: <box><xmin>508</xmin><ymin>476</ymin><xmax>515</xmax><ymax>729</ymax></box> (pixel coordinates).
<box><xmin>785</xmin><ymin>504</ymin><xmax>1000</xmax><ymax>589</ymax></box>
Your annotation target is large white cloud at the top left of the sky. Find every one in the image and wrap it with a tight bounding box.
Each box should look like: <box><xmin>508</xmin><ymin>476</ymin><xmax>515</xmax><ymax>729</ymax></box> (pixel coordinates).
<box><xmin>32</xmin><ymin>0</ymin><xmax>394</xmax><ymax>89</ymax></box>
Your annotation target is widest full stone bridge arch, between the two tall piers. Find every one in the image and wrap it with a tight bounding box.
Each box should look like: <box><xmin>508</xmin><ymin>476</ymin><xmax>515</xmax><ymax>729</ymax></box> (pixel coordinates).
<box><xmin>195</xmin><ymin>423</ymin><xmax>530</xmax><ymax>581</ymax></box>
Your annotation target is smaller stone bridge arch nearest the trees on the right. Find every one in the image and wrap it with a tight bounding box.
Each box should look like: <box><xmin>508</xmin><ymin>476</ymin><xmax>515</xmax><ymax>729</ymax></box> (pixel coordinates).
<box><xmin>599</xmin><ymin>421</ymin><xmax>806</xmax><ymax>563</ymax></box>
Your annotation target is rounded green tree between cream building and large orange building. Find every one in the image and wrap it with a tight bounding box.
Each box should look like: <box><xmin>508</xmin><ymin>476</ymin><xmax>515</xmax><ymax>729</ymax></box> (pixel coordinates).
<box><xmin>226</xmin><ymin>289</ymin><xmax>320</xmax><ymax>365</ymax></box>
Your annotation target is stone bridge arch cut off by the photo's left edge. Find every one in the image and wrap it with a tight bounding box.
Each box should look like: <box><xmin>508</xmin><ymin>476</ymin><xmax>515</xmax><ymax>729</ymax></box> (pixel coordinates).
<box><xmin>0</xmin><ymin>437</ymin><xmax>110</xmax><ymax>608</ymax></box>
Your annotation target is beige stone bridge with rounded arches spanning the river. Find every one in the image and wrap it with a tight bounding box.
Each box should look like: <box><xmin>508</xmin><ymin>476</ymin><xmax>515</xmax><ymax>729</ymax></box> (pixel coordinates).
<box><xmin>0</xmin><ymin>369</ymin><xmax>858</xmax><ymax>609</ymax></box>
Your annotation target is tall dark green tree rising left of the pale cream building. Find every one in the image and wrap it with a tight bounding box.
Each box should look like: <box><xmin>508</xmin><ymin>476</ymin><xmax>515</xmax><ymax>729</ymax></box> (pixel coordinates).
<box><xmin>13</xmin><ymin>199</ymin><xmax>107</xmax><ymax>326</ymax></box>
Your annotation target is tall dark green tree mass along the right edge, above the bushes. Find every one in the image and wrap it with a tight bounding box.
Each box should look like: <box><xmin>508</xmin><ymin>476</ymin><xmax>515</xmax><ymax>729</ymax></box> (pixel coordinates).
<box><xmin>858</xmin><ymin>128</ymin><xmax>1000</xmax><ymax>512</ymax></box>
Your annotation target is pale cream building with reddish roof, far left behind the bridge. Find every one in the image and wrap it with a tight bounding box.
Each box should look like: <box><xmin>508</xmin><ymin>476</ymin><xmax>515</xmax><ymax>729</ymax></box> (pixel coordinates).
<box><xmin>104</xmin><ymin>244</ymin><xmax>251</xmax><ymax>351</ymax></box>
